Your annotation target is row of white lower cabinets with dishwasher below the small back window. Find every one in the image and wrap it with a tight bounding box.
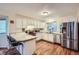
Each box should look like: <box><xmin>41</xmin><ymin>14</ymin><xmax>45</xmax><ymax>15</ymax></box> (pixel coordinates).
<box><xmin>36</xmin><ymin>32</ymin><xmax>61</xmax><ymax>43</ymax></box>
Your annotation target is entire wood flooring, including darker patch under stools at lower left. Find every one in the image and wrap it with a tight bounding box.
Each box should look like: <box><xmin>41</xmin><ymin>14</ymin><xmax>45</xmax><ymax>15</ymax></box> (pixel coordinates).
<box><xmin>0</xmin><ymin>41</ymin><xmax>79</xmax><ymax>55</ymax></box>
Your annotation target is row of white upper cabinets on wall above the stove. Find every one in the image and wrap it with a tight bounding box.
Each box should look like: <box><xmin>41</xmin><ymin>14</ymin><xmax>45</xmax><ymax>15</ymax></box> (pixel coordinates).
<box><xmin>16</xmin><ymin>17</ymin><xmax>45</xmax><ymax>29</ymax></box>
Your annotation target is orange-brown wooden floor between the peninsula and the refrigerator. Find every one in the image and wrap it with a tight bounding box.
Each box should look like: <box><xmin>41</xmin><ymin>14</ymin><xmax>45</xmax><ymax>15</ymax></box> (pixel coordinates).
<box><xmin>34</xmin><ymin>41</ymin><xmax>79</xmax><ymax>55</ymax></box>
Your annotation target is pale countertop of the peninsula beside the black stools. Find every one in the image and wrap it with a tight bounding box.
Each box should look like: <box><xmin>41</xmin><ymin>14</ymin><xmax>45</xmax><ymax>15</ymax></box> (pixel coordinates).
<box><xmin>11</xmin><ymin>33</ymin><xmax>37</xmax><ymax>42</ymax></box>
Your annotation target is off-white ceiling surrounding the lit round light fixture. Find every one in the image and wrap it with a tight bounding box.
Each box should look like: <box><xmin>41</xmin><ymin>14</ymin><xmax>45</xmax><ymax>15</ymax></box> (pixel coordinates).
<box><xmin>0</xmin><ymin>3</ymin><xmax>79</xmax><ymax>18</ymax></box>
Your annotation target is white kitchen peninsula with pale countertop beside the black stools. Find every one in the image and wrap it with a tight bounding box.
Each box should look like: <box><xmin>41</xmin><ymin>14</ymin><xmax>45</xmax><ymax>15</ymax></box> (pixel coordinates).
<box><xmin>10</xmin><ymin>32</ymin><xmax>37</xmax><ymax>55</ymax></box>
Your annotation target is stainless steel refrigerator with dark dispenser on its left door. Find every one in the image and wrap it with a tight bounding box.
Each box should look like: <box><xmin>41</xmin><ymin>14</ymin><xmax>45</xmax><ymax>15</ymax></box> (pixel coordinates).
<box><xmin>61</xmin><ymin>22</ymin><xmax>79</xmax><ymax>50</ymax></box>
